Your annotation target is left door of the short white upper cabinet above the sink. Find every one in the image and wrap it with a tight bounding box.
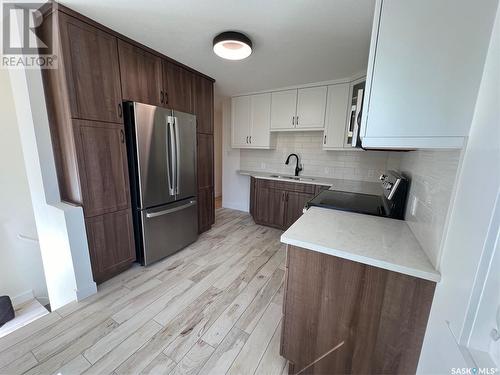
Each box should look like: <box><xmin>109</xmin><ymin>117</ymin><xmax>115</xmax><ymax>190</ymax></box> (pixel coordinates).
<box><xmin>271</xmin><ymin>89</ymin><xmax>297</xmax><ymax>130</ymax></box>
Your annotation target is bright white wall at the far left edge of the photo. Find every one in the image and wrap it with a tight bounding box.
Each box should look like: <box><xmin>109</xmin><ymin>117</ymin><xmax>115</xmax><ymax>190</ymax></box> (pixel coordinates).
<box><xmin>0</xmin><ymin>69</ymin><xmax>48</xmax><ymax>303</ymax></box>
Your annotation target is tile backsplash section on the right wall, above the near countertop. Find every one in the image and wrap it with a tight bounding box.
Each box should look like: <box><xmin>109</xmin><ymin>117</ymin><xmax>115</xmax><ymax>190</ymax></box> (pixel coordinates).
<box><xmin>387</xmin><ymin>150</ymin><xmax>461</xmax><ymax>268</ymax></box>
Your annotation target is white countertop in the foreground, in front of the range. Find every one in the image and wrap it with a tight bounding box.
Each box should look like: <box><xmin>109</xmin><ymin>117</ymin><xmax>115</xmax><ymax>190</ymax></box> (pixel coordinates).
<box><xmin>281</xmin><ymin>207</ymin><xmax>441</xmax><ymax>282</ymax></box>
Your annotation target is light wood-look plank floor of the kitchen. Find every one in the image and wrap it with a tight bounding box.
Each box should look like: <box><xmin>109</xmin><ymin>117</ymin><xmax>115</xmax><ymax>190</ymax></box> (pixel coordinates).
<box><xmin>0</xmin><ymin>209</ymin><xmax>287</xmax><ymax>375</ymax></box>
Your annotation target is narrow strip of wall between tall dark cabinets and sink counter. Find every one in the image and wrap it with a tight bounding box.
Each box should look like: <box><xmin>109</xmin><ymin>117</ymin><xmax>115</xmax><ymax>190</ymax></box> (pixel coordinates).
<box><xmin>222</xmin><ymin>98</ymin><xmax>250</xmax><ymax>211</ymax></box>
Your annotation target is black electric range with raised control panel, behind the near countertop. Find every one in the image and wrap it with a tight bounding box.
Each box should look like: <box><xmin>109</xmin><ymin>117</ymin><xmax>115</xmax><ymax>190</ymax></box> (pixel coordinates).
<box><xmin>305</xmin><ymin>171</ymin><xmax>408</xmax><ymax>220</ymax></box>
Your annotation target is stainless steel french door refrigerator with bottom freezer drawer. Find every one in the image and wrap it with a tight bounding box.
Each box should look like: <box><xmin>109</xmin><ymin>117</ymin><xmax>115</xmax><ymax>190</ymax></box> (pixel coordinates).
<box><xmin>124</xmin><ymin>102</ymin><xmax>198</xmax><ymax>265</ymax></box>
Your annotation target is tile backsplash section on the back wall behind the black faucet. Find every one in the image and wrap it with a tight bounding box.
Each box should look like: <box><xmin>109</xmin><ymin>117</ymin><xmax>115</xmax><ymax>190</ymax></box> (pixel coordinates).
<box><xmin>240</xmin><ymin>132</ymin><xmax>400</xmax><ymax>181</ymax></box>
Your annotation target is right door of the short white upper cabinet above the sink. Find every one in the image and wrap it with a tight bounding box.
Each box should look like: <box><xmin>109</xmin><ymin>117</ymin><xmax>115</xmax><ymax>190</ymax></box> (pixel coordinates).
<box><xmin>295</xmin><ymin>86</ymin><xmax>327</xmax><ymax>130</ymax></box>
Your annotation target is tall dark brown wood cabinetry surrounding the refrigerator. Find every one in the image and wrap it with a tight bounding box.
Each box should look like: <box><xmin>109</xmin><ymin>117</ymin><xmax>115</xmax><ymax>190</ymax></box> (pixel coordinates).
<box><xmin>36</xmin><ymin>5</ymin><xmax>214</xmax><ymax>282</ymax></box>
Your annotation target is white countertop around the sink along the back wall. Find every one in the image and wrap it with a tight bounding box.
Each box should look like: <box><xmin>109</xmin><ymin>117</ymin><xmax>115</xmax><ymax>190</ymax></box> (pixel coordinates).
<box><xmin>238</xmin><ymin>170</ymin><xmax>382</xmax><ymax>194</ymax></box>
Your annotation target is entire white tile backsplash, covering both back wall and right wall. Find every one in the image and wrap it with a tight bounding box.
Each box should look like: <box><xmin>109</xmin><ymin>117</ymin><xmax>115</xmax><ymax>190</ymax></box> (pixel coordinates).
<box><xmin>240</xmin><ymin>132</ymin><xmax>461</xmax><ymax>267</ymax></box>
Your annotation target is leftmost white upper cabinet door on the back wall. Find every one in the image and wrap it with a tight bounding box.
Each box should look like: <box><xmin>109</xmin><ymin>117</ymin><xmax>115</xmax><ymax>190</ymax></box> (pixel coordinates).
<box><xmin>231</xmin><ymin>95</ymin><xmax>250</xmax><ymax>148</ymax></box>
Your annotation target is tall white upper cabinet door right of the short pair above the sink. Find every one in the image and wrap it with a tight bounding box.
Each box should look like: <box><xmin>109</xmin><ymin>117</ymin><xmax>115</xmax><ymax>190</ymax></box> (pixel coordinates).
<box><xmin>323</xmin><ymin>83</ymin><xmax>350</xmax><ymax>150</ymax></box>
